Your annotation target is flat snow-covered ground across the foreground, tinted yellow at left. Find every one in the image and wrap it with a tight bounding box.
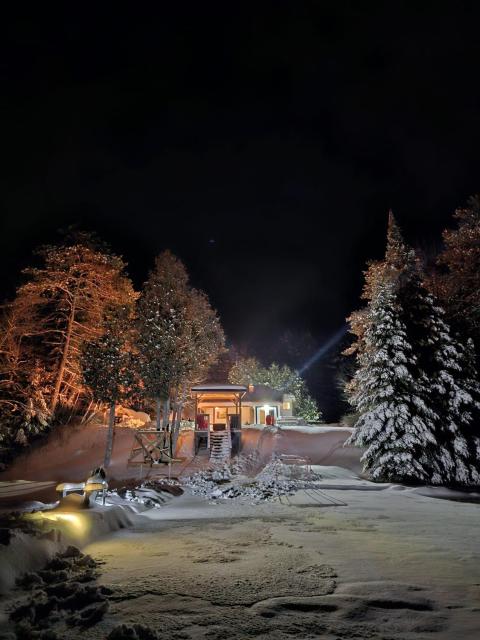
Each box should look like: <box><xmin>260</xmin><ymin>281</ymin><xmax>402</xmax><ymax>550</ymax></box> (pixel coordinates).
<box><xmin>0</xmin><ymin>430</ymin><xmax>480</xmax><ymax>640</ymax></box>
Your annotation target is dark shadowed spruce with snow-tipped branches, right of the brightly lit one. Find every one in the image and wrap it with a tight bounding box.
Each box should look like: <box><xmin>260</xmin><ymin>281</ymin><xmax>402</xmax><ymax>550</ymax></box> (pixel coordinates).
<box><xmin>396</xmin><ymin>228</ymin><xmax>478</xmax><ymax>485</ymax></box>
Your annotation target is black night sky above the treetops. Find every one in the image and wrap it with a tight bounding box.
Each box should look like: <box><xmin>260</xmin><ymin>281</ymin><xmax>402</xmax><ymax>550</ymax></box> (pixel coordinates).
<box><xmin>0</xmin><ymin>5</ymin><xmax>480</xmax><ymax>420</ymax></box>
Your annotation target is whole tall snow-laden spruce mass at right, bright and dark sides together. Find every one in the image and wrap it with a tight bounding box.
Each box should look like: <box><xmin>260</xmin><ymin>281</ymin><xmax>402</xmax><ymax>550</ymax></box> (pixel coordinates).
<box><xmin>347</xmin><ymin>213</ymin><xmax>480</xmax><ymax>486</ymax></box>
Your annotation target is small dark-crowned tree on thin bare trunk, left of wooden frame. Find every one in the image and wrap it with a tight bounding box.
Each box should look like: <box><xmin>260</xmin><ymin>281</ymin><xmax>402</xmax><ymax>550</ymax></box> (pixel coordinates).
<box><xmin>82</xmin><ymin>307</ymin><xmax>135</xmax><ymax>468</ymax></box>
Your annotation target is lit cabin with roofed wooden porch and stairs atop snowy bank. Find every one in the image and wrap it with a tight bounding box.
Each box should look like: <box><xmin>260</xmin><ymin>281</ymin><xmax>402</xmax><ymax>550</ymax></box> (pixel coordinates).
<box><xmin>191</xmin><ymin>384</ymin><xmax>293</xmax><ymax>460</ymax></box>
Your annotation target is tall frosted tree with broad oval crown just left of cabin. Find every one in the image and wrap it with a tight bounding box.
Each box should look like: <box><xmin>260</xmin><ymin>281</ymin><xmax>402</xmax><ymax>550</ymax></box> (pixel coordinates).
<box><xmin>137</xmin><ymin>251</ymin><xmax>225</xmax><ymax>444</ymax></box>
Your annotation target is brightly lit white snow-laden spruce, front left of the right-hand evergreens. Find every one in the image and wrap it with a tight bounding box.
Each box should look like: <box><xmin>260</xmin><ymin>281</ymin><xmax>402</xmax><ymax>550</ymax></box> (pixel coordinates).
<box><xmin>346</xmin><ymin>281</ymin><xmax>436</xmax><ymax>482</ymax></box>
